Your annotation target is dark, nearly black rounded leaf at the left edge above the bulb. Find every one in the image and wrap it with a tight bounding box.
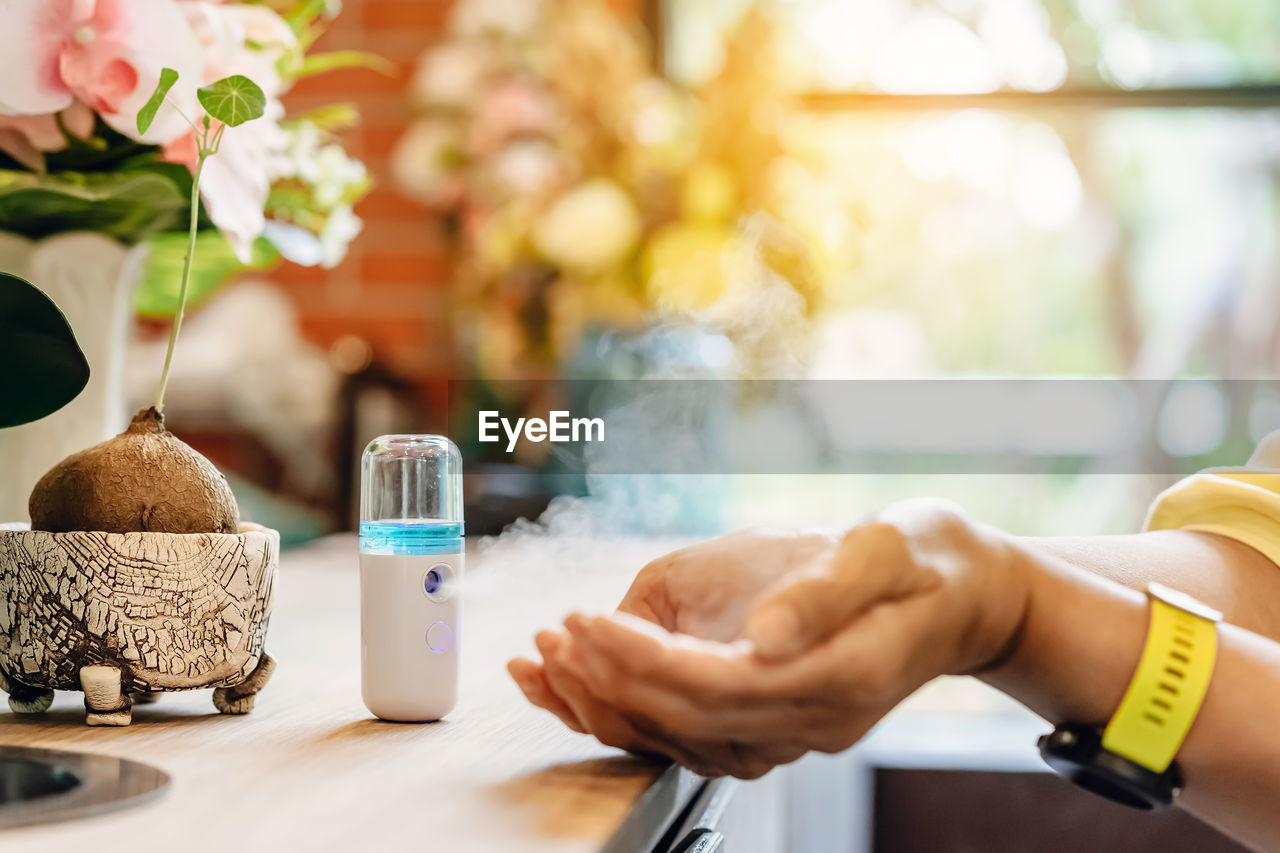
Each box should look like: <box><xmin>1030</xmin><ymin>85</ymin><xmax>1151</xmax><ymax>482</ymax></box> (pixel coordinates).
<box><xmin>0</xmin><ymin>273</ymin><xmax>88</xmax><ymax>427</ymax></box>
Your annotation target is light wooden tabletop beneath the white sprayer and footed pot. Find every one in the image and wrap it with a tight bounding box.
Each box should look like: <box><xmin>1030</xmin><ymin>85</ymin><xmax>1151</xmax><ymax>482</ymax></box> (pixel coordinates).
<box><xmin>0</xmin><ymin>537</ymin><xmax>732</xmax><ymax>853</ymax></box>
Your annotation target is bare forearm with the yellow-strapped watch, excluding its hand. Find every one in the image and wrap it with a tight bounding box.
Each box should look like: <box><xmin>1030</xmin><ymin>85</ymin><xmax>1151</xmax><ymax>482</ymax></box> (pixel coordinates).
<box><xmin>982</xmin><ymin>534</ymin><xmax>1280</xmax><ymax>849</ymax></box>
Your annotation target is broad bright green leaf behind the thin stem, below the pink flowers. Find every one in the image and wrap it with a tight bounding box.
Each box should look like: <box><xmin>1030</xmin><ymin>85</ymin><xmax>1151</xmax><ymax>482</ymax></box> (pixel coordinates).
<box><xmin>134</xmin><ymin>231</ymin><xmax>279</xmax><ymax>319</ymax></box>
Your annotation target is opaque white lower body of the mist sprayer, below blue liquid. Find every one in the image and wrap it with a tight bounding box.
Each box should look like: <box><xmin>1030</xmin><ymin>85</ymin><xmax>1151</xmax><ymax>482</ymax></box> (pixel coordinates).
<box><xmin>360</xmin><ymin>553</ymin><xmax>463</xmax><ymax>722</ymax></box>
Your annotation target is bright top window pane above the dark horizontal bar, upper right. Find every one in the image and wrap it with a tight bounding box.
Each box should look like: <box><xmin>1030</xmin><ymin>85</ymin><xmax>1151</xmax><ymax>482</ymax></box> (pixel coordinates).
<box><xmin>664</xmin><ymin>0</ymin><xmax>1280</xmax><ymax>92</ymax></box>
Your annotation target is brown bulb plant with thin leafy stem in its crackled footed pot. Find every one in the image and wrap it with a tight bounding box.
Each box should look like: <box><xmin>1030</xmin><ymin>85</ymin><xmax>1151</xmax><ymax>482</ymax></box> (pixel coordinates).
<box><xmin>0</xmin><ymin>68</ymin><xmax>279</xmax><ymax>726</ymax></box>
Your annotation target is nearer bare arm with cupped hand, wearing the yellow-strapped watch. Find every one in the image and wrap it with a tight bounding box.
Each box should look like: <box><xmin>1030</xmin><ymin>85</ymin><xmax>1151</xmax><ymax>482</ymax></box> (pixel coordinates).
<box><xmin>513</xmin><ymin>502</ymin><xmax>1280</xmax><ymax>848</ymax></box>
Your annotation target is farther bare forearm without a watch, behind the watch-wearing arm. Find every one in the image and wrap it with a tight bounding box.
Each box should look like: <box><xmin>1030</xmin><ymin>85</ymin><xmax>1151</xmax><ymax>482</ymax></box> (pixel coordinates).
<box><xmin>1019</xmin><ymin>530</ymin><xmax>1280</xmax><ymax>639</ymax></box>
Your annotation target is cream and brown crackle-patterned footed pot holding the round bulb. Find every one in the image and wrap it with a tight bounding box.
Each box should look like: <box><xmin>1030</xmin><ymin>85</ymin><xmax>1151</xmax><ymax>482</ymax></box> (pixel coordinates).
<box><xmin>0</xmin><ymin>517</ymin><xmax>280</xmax><ymax>725</ymax></box>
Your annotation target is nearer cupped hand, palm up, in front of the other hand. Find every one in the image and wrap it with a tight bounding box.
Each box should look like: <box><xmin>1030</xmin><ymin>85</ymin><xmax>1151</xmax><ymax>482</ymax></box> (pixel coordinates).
<box><xmin>513</xmin><ymin>502</ymin><xmax>1027</xmax><ymax>777</ymax></box>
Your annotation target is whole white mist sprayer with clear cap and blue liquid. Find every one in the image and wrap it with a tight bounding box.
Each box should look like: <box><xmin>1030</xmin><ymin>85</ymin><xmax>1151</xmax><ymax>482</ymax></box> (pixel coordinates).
<box><xmin>360</xmin><ymin>435</ymin><xmax>463</xmax><ymax>722</ymax></box>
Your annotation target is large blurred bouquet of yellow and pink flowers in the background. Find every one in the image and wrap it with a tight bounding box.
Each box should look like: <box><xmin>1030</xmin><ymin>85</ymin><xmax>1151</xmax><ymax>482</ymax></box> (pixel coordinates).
<box><xmin>396</xmin><ymin>0</ymin><xmax>847</xmax><ymax>375</ymax></box>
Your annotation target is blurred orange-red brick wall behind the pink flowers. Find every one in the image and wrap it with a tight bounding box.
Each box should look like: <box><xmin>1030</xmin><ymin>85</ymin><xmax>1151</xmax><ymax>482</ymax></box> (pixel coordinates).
<box><xmin>274</xmin><ymin>0</ymin><xmax>646</xmax><ymax>397</ymax></box>
